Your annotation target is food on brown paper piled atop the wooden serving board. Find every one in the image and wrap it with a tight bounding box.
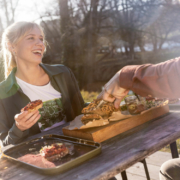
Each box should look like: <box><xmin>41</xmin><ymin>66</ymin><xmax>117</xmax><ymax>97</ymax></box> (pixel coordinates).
<box><xmin>67</xmin><ymin>96</ymin><xmax>168</xmax><ymax>130</ymax></box>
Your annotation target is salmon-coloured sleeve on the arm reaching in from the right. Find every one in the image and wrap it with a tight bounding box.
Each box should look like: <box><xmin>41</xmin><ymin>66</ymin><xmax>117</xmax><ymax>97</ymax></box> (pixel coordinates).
<box><xmin>120</xmin><ymin>58</ymin><xmax>180</xmax><ymax>98</ymax></box>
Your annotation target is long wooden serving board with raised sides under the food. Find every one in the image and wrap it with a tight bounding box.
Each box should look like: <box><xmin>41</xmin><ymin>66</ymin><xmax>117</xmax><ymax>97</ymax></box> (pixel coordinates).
<box><xmin>63</xmin><ymin>104</ymin><xmax>169</xmax><ymax>142</ymax></box>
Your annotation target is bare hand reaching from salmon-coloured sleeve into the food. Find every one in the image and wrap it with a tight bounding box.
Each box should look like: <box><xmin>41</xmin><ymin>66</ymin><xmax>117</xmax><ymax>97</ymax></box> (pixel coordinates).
<box><xmin>97</xmin><ymin>70</ymin><xmax>129</xmax><ymax>108</ymax></box>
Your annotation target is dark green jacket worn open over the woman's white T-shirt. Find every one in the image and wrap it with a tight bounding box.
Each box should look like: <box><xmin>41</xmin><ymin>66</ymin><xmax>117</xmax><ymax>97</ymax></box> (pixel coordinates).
<box><xmin>0</xmin><ymin>64</ymin><xmax>84</xmax><ymax>147</ymax></box>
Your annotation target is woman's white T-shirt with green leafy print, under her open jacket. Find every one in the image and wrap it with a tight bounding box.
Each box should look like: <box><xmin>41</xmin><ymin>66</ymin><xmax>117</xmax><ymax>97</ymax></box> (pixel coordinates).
<box><xmin>16</xmin><ymin>77</ymin><xmax>66</xmax><ymax>131</ymax></box>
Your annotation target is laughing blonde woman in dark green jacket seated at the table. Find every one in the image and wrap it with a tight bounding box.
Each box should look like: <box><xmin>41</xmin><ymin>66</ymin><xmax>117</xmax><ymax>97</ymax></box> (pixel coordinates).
<box><xmin>0</xmin><ymin>22</ymin><xmax>84</xmax><ymax>146</ymax></box>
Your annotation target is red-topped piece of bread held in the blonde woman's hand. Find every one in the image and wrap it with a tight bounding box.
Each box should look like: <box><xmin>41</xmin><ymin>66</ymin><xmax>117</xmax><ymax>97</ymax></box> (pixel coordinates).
<box><xmin>21</xmin><ymin>100</ymin><xmax>43</xmax><ymax>112</ymax></box>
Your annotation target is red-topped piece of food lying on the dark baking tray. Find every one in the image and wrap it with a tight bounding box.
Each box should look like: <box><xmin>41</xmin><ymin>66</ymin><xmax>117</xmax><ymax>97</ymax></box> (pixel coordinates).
<box><xmin>40</xmin><ymin>143</ymin><xmax>69</xmax><ymax>161</ymax></box>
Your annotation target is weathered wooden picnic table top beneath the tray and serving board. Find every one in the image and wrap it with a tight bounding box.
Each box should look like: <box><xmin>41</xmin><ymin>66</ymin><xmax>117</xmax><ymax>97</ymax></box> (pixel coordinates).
<box><xmin>0</xmin><ymin>107</ymin><xmax>180</xmax><ymax>180</ymax></box>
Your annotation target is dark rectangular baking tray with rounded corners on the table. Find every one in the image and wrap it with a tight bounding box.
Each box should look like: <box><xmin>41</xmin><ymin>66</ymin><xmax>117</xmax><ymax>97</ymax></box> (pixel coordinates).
<box><xmin>3</xmin><ymin>134</ymin><xmax>101</xmax><ymax>174</ymax></box>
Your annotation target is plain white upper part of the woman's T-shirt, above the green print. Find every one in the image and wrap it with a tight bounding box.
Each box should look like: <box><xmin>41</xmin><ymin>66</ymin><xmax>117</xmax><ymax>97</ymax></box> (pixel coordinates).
<box><xmin>16</xmin><ymin>77</ymin><xmax>61</xmax><ymax>102</ymax></box>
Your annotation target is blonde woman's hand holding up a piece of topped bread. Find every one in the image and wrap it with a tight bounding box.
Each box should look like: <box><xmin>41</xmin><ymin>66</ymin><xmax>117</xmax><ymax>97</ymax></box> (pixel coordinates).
<box><xmin>14</xmin><ymin>110</ymin><xmax>41</xmax><ymax>131</ymax></box>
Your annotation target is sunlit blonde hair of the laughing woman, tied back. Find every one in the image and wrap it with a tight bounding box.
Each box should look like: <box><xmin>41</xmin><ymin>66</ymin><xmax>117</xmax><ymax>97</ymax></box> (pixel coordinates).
<box><xmin>1</xmin><ymin>21</ymin><xmax>47</xmax><ymax>78</ymax></box>
